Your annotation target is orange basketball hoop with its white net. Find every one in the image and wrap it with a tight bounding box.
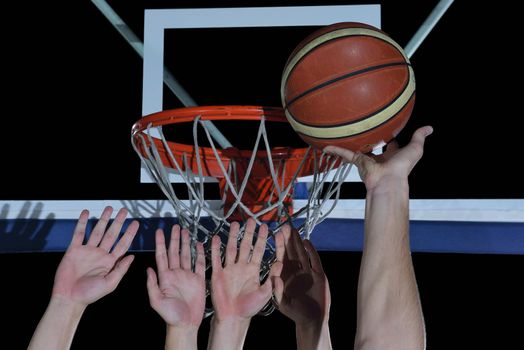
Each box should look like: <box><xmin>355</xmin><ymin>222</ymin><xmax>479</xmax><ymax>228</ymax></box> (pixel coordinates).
<box><xmin>131</xmin><ymin>106</ymin><xmax>351</xmax><ymax>314</ymax></box>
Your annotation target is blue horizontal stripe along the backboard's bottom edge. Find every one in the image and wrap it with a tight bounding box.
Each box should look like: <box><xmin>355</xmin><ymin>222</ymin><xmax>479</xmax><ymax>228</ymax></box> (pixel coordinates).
<box><xmin>0</xmin><ymin>218</ymin><xmax>524</xmax><ymax>254</ymax></box>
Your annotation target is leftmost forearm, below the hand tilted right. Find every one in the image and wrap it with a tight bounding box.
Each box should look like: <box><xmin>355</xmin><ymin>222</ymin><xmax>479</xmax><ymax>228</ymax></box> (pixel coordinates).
<box><xmin>28</xmin><ymin>297</ymin><xmax>85</xmax><ymax>350</ymax></box>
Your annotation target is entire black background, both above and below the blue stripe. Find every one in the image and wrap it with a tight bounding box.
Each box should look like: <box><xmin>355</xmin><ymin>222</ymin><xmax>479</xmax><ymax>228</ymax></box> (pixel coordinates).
<box><xmin>0</xmin><ymin>0</ymin><xmax>524</xmax><ymax>349</ymax></box>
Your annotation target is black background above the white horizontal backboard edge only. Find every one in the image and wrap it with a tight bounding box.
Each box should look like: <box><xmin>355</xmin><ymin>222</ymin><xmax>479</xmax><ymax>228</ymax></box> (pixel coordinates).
<box><xmin>0</xmin><ymin>0</ymin><xmax>524</xmax><ymax>200</ymax></box>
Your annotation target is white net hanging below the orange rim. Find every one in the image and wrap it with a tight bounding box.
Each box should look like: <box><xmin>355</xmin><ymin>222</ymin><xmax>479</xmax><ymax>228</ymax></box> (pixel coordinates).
<box><xmin>132</xmin><ymin>106</ymin><xmax>351</xmax><ymax>314</ymax></box>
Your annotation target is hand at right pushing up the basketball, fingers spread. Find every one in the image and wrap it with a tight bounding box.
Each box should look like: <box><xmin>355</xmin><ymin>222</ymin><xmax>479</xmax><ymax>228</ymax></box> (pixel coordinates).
<box><xmin>324</xmin><ymin>126</ymin><xmax>433</xmax><ymax>190</ymax></box>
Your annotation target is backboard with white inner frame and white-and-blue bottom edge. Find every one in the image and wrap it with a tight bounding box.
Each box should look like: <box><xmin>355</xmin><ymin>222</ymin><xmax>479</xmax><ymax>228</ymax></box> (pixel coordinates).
<box><xmin>0</xmin><ymin>0</ymin><xmax>524</xmax><ymax>253</ymax></box>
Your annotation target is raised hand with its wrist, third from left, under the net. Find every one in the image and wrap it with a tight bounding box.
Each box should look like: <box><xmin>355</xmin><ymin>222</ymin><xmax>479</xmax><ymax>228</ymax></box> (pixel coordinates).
<box><xmin>208</xmin><ymin>219</ymin><xmax>284</xmax><ymax>350</ymax></box>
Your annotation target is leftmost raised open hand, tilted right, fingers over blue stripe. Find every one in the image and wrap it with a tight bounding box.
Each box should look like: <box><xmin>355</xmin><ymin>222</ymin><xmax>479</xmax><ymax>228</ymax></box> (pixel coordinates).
<box><xmin>52</xmin><ymin>207</ymin><xmax>139</xmax><ymax>305</ymax></box>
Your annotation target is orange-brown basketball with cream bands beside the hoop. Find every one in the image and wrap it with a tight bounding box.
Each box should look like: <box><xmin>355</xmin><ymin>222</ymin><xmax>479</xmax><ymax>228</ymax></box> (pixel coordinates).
<box><xmin>281</xmin><ymin>22</ymin><xmax>415</xmax><ymax>153</ymax></box>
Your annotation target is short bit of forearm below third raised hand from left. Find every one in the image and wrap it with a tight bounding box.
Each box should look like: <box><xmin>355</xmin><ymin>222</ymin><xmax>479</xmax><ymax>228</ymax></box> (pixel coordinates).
<box><xmin>207</xmin><ymin>317</ymin><xmax>250</xmax><ymax>350</ymax></box>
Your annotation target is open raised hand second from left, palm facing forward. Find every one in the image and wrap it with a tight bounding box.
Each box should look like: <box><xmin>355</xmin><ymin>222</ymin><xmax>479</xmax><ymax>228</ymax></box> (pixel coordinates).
<box><xmin>147</xmin><ymin>225</ymin><xmax>206</xmax><ymax>329</ymax></box>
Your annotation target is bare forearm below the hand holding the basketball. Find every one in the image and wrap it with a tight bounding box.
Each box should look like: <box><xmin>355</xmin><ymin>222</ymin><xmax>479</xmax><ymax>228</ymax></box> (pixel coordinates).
<box><xmin>355</xmin><ymin>179</ymin><xmax>425</xmax><ymax>349</ymax></box>
